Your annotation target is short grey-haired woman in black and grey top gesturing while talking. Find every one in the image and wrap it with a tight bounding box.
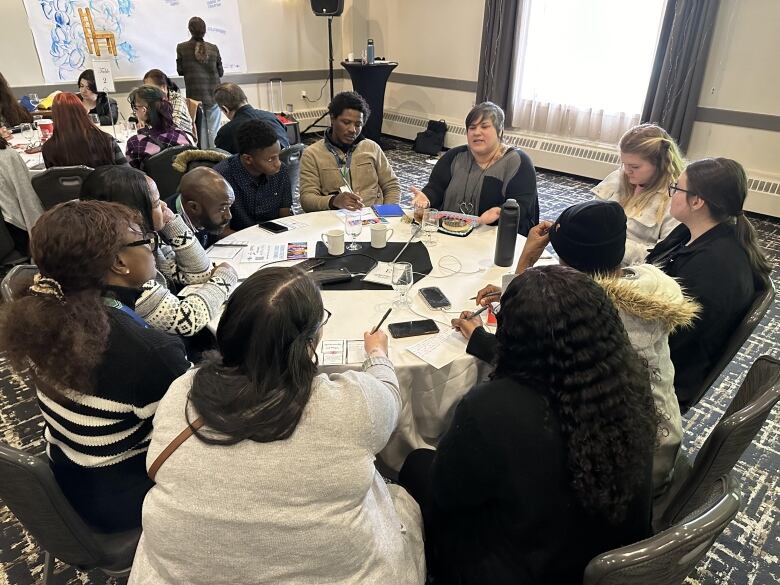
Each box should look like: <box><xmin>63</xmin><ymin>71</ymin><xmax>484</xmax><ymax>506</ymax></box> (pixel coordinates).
<box><xmin>412</xmin><ymin>102</ymin><xmax>539</xmax><ymax>236</ymax></box>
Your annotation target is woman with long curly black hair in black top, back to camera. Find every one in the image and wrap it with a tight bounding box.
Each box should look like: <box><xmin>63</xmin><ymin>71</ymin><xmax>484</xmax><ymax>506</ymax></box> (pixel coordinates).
<box><xmin>400</xmin><ymin>266</ymin><xmax>658</xmax><ymax>585</ymax></box>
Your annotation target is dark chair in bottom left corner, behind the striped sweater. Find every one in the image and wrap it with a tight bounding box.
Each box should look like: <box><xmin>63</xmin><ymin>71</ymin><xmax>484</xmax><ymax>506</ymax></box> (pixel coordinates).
<box><xmin>0</xmin><ymin>443</ymin><xmax>141</xmax><ymax>585</ymax></box>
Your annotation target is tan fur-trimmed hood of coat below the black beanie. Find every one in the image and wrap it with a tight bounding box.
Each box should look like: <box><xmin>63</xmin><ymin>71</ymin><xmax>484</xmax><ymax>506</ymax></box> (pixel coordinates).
<box><xmin>595</xmin><ymin>264</ymin><xmax>701</xmax><ymax>332</ymax></box>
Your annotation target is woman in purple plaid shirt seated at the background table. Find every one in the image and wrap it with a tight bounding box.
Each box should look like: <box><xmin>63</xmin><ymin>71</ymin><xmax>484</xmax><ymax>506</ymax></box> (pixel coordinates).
<box><xmin>125</xmin><ymin>85</ymin><xmax>191</xmax><ymax>169</ymax></box>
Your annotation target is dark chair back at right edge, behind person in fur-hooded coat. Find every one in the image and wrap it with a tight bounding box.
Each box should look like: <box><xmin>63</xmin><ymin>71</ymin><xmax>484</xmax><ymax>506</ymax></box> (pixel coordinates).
<box><xmin>653</xmin><ymin>355</ymin><xmax>780</xmax><ymax>530</ymax></box>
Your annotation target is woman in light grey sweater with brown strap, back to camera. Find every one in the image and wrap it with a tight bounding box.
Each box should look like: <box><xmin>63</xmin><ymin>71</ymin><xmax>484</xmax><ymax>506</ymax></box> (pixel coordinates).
<box><xmin>130</xmin><ymin>267</ymin><xmax>425</xmax><ymax>585</ymax></box>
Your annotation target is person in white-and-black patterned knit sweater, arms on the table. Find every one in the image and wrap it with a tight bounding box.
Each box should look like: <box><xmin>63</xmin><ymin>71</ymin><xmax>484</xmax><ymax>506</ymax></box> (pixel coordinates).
<box><xmin>81</xmin><ymin>166</ymin><xmax>238</xmax><ymax>340</ymax></box>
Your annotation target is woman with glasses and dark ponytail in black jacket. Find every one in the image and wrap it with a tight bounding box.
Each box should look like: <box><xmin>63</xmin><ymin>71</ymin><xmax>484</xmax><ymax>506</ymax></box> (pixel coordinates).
<box><xmin>647</xmin><ymin>158</ymin><xmax>772</xmax><ymax>412</ymax></box>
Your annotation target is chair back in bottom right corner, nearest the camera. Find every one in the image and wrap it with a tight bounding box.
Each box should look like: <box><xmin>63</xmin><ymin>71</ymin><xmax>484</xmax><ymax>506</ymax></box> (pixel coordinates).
<box><xmin>583</xmin><ymin>475</ymin><xmax>741</xmax><ymax>585</ymax></box>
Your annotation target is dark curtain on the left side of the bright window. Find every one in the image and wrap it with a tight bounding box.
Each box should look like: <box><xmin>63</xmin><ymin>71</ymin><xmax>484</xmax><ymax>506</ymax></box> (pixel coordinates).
<box><xmin>477</xmin><ymin>0</ymin><xmax>522</xmax><ymax>112</ymax></box>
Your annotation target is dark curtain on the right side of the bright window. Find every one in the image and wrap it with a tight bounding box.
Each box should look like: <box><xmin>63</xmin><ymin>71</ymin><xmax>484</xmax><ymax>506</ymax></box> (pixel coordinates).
<box><xmin>642</xmin><ymin>0</ymin><xmax>720</xmax><ymax>151</ymax></box>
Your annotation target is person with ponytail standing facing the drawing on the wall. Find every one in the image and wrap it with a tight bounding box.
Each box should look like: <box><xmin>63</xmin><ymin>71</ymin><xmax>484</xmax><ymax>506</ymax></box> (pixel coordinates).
<box><xmin>176</xmin><ymin>16</ymin><xmax>224</xmax><ymax>148</ymax></box>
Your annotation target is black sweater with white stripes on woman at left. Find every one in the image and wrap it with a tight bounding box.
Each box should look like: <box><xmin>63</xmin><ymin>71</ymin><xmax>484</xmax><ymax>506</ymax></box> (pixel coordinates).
<box><xmin>28</xmin><ymin>308</ymin><xmax>190</xmax><ymax>531</ymax></box>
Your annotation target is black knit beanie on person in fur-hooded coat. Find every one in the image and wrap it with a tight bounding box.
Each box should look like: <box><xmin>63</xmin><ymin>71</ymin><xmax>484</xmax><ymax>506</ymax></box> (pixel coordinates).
<box><xmin>549</xmin><ymin>199</ymin><xmax>626</xmax><ymax>274</ymax></box>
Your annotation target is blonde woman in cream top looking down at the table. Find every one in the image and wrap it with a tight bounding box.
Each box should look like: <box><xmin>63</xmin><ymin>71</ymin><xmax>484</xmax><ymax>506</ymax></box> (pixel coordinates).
<box><xmin>593</xmin><ymin>124</ymin><xmax>684</xmax><ymax>266</ymax></box>
